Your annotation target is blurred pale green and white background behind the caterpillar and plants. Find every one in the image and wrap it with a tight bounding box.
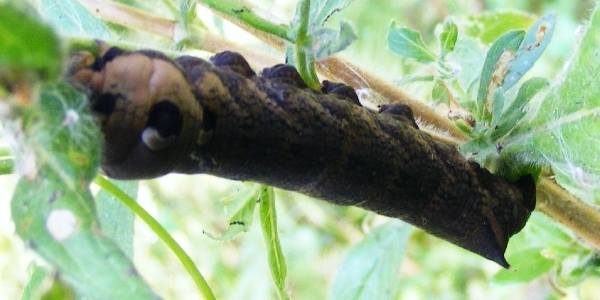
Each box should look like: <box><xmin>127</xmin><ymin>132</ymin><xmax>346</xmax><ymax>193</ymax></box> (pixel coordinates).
<box><xmin>0</xmin><ymin>0</ymin><xmax>600</xmax><ymax>300</ymax></box>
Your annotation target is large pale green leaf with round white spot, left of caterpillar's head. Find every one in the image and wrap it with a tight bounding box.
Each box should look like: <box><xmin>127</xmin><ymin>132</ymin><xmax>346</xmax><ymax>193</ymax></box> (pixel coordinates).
<box><xmin>11</xmin><ymin>83</ymin><xmax>157</xmax><ymax>299</ymax></box>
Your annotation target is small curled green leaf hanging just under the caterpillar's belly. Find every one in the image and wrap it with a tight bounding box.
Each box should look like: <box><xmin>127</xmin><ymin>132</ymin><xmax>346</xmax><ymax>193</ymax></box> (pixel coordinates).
<box><xmin>205</xmin><ymin>183</ymin><xmax>262</xmax><ymax>241</ymax></box>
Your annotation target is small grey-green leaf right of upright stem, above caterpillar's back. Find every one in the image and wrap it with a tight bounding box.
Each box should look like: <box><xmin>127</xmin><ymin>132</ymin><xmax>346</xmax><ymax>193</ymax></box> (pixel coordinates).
<box><xmin>312</xmin><ymin>22</ymin><xmax>358</xmax><ymax>60</ymax></box>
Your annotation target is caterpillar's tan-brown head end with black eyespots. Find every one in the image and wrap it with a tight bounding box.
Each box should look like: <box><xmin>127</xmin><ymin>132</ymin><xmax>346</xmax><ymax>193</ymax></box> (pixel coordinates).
<box><xmin>73</xmin><ymin>48</ymin><xmax>202</xmax><ymax>179</ymax></box>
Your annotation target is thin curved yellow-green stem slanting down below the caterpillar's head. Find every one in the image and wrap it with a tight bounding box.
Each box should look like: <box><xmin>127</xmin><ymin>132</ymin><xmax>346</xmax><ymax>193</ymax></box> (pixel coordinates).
<box><xmin>94</xmin><ymin>176</ymin><xmax>215</xmax><ymax>300</ymax></box>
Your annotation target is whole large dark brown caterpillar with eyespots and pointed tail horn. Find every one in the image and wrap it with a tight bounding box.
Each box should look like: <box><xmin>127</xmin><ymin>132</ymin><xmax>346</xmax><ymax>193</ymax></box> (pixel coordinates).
<box><xmin>73</xmin><ymin>48</ymin><xmax>535</xmax><ymax>267</ymax></box>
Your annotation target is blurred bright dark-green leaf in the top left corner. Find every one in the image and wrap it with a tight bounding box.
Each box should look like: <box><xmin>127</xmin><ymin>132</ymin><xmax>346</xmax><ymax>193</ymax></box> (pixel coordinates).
<box><xmin>0</xmin><ymin>2</ymin><xmax>62</xmax><ymax>80</ymax></box>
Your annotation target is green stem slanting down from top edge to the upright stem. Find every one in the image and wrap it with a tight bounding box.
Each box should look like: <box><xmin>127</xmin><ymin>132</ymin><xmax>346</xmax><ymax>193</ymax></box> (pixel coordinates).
<box><xmin>198</xmin><ymin>0</ymin><xmax>293</xmax><ymax>43</ymax></box>
